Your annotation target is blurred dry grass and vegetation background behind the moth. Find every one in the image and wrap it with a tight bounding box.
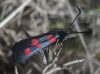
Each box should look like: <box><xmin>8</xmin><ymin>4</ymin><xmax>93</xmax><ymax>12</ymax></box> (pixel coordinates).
<box><xmin>0</xmin><ymin>0</ymin><xmax>100</xmax><ymax>74</ymax></box>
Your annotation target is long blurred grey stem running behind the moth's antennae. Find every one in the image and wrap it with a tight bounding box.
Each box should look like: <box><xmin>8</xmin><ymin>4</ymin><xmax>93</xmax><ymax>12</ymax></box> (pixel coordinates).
<box><xmin>66</xmin><ymin>0</ymin><xmax>94</xmax><ymax>74</ymax></box>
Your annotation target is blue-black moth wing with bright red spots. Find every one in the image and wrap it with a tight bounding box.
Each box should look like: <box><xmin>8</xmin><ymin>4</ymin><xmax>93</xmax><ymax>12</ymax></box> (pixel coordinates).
<box><xmin>12</xmin><ymin>33</ymin><xmax>57</xmax><ymax>62</ymax></box>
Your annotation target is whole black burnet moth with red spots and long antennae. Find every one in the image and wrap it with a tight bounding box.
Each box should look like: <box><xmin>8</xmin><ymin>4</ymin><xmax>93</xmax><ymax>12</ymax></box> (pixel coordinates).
<box><xmin>12</xmin><ymin>7</ymin><xmax>90</xmax><ymax>63</ymax></box>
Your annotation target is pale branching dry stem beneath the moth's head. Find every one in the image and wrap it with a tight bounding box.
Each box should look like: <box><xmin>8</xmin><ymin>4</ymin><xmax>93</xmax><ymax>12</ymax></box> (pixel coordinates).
<box><xmin>42</xmin><ymin>44</ymin><xmax>84</xmax><ymax>74</ymax></box>
